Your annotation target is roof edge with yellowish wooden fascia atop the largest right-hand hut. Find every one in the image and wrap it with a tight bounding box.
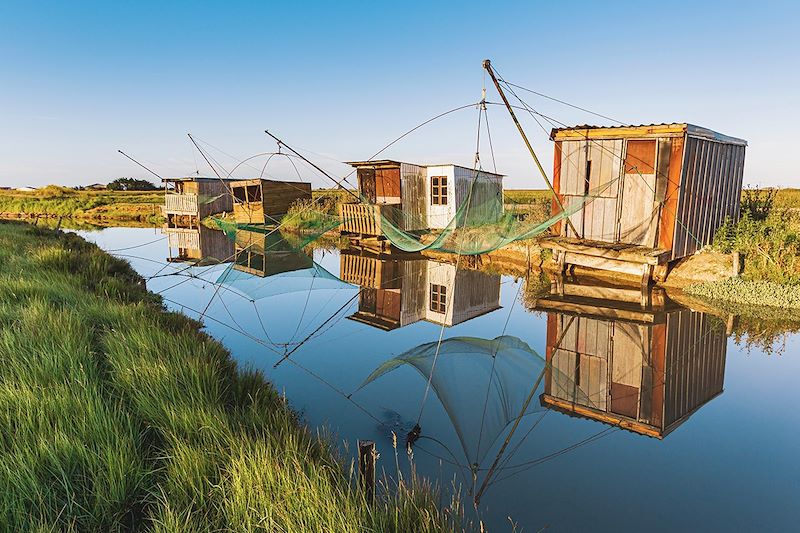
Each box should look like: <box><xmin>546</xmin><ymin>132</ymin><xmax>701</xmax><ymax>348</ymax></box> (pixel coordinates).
<box><xmin>550</xmin><ymin>122</ymin><xmax>747</xmax><ymax>146</ymax></box>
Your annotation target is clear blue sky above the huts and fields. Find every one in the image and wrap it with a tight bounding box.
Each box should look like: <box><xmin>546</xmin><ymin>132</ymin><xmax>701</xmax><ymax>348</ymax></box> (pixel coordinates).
<box><xmin>0</xmin><ymin>0</ymin><xmax>800</xmax><ymax>188</ymax></box>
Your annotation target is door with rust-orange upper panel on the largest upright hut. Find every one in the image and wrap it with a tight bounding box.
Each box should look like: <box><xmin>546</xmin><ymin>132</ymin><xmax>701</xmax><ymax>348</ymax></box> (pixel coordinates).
<box><xmin>619</xmin><ymin>139</ymin><xmax>659</xmax><ymax>247</ymax></box>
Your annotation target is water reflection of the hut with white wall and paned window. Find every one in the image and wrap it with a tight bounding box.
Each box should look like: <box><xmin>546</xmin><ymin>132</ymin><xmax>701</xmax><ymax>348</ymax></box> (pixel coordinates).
<box><xmin>340</xmin><ymin>251</ymin><xmax>500</xmax><ymax>331</ymax></box>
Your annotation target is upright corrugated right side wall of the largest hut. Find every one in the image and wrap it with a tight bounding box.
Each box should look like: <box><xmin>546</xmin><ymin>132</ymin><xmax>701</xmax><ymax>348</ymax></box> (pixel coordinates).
<box><xmin>672</xmin><ymin>137</ymin><xmax>745</xmax><ymax>259</ymax></box>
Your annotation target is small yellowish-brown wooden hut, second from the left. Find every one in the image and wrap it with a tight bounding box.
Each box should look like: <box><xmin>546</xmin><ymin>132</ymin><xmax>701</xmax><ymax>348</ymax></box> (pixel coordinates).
<box><xmin>231</xmin><ymin>179</ymin><xmax>311</xmax><ymax>224</ymax></box>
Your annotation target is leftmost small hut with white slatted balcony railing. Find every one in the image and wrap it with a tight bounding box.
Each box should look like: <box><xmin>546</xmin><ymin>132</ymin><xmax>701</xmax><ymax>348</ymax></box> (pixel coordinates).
<box><xmin>164</xmin><ymin>176</ymin><xmax>233</xmax><ymax>226</ymax></box>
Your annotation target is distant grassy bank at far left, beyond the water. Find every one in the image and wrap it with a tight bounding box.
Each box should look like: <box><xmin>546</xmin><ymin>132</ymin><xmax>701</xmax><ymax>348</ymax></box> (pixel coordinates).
<box><xmin>0</xmin><ymin>185</ymin><xmax>164</xmax><ymax>221</ymax></box>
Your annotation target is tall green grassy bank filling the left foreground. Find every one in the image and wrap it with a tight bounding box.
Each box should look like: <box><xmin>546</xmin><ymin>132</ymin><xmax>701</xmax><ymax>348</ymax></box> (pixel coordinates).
<box><xmin>0</xmin><ymin>219</ymin><xmax>457</xmax><ymax>531</ymax></box>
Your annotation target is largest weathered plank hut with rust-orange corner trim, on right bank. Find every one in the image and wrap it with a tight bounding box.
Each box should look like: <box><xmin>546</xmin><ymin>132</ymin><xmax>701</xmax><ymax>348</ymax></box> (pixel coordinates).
<box><xmin>542</xmin><ymin>124</ymin><xmax>747</xmax><ymax>280</ymax></box>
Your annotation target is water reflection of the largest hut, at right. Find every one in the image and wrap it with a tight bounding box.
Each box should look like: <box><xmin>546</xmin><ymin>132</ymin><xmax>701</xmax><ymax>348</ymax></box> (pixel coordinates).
<box><xmin>534</xmin><ymin>274</ymin><xmax>726</xmax><ymax>438</ymax></box>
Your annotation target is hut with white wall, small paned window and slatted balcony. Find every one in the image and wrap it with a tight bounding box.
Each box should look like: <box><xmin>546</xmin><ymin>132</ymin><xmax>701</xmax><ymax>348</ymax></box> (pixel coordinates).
<box><xmin>339</xmin><ymin>159</ymin><xmax>503</xmax><ymax>237</ymax></box>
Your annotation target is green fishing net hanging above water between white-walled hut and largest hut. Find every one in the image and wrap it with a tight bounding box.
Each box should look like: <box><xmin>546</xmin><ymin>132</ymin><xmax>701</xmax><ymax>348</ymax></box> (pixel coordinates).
<box><xmin>380</xmin><ymin>173</ymin><xmax>612</xmax><ymax>255</ymax></box>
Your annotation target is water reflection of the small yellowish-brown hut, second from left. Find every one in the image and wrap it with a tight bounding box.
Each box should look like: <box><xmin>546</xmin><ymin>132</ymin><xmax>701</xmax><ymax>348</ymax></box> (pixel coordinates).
<box><xmin>233</xmin><ymin>229</ymin><xmax>314</xmax><ymax>277</ymax></box>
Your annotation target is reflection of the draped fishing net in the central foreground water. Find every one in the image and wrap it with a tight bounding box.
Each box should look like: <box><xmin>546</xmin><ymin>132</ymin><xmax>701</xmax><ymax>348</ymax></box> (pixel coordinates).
<box><xmin>361</xmin><ymin>336</ymin><xmax>592</xmax><ymax>465</ymax></box>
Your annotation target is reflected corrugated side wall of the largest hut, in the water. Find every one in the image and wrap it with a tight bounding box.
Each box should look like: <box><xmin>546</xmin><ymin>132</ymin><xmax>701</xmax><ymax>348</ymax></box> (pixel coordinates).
<box><xmin>664</xmin><ymin>309</ymin><xmax>727</xmax><ymax>428</ymax></box>
